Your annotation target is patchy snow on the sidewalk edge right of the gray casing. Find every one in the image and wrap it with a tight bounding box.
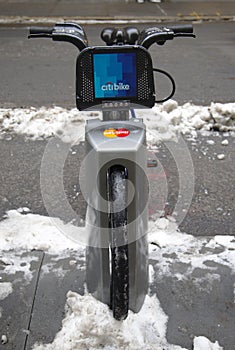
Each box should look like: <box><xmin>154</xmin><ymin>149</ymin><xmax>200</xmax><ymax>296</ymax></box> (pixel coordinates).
<box><xmin>149</xmin><ymin>217</ymin><xmax>235</xmax><ymax>282</ymax></box>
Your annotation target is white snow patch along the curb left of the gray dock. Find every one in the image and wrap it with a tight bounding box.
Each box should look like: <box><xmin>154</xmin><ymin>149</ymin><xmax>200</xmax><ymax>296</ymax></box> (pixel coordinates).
<box><xmin>0</xmin><ymin>209</ymin><xmax>85</xmax><ymax>253</ymax></box>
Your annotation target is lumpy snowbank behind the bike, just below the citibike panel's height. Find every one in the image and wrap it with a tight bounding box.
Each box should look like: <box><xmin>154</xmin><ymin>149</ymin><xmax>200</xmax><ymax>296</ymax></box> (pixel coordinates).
<box><xmin>0</xmin><ymin>100</ymin><xmax>235</xmax><ymax>143</ymax></box>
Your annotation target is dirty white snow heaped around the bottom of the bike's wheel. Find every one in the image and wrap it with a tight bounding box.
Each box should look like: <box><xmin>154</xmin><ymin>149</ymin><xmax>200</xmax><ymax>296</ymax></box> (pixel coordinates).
<box><xmin>33</xmin><ymin>291</ymin><xmax>222</xmax><ymax>350</ymax></box>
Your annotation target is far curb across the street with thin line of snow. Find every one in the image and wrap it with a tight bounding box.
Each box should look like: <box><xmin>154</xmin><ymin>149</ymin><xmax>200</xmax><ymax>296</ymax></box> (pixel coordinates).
<box><xmin>0</xmin><ymin>15</ymin><xmax>235</xmax><ymax>27</ymax></box>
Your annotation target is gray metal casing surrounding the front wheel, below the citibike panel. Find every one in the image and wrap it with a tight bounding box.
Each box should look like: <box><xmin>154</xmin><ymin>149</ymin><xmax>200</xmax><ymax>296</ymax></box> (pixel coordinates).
<box><xmin>85</xmin><ymin>101</ymin><xmax>148</xmax><ymax>312</ymax></box>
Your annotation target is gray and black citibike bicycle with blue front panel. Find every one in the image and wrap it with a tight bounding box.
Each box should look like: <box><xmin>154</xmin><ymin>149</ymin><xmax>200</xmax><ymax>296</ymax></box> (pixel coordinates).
<box><xmin>29</xmin><ymin>22</ymin><xmax>195</xmax><ymax>320</ymax></box>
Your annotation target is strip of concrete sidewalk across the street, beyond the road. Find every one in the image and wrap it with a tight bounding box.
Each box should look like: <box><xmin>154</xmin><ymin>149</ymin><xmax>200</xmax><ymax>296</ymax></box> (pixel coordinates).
<box><xmin>0</xmin><ymin>0</ymin><xmax>235</xmax><ymax>25</ymax></box>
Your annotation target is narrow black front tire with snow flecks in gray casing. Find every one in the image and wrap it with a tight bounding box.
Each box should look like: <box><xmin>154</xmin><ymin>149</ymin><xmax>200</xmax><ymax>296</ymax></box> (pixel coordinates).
<box><xmin>107</xmin><ymin>165</ymin><xmax>129</xmax><ymax>320</ymax></box>
